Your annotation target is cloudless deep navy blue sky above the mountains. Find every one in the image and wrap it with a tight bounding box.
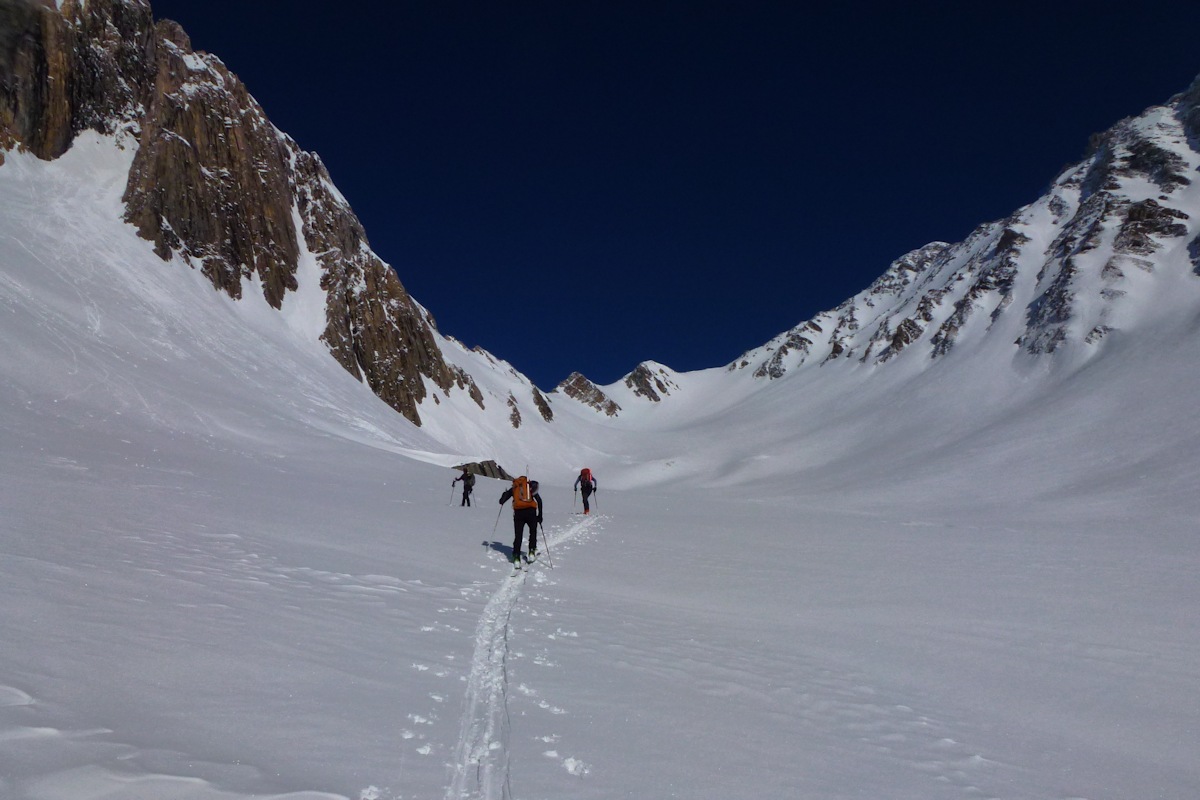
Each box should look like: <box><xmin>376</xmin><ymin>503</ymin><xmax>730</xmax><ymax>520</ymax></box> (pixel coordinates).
<box><xmin>151</xmin><ymin>0</ymin><xmax>1200</xmax><ymax>390</ymax></box>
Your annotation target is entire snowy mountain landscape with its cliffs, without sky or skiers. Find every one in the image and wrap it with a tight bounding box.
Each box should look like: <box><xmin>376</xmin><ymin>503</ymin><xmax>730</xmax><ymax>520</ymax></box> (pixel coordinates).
<box><xmin>0</xmin><ymin>0</ymin><xmax>1200</xmax><ymax>800</ymax></box>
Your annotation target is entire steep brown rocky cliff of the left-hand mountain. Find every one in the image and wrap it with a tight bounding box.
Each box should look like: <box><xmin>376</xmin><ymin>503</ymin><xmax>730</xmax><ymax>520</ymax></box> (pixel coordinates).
<box><xmin>0</xmin><ymin>0</ymin><xmax>468</xmax><ymax>425</ymax></box>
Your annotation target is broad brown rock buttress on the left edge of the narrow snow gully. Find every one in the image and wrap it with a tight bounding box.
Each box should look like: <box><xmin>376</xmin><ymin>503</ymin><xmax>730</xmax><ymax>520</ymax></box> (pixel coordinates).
<box><xmin>125</xmin><ymin>20</ymin><xmax>300</xmax><ymax>308</ymax></box>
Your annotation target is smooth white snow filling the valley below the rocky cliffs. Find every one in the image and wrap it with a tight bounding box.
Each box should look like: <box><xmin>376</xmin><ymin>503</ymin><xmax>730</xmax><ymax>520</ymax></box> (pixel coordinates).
<box><xmin>0</xmin><ymin>136</ymin><xmax>1200</xmax><ymax>800</ymax></box>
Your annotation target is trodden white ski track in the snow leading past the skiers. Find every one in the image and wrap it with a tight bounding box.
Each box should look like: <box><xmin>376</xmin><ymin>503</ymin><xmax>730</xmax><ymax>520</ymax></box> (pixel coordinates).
<box><xmin>445</xmin><ymin>515</ymin><xmax>599</xmax><ymax>800</ymax></box>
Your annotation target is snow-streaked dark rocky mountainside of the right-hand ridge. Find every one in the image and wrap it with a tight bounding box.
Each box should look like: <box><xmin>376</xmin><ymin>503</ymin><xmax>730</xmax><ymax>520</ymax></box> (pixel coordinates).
<box><xmin>728</xmin><ymin>79</ymin><xmax>1200</xmax><ymax>379</ymax></box>
